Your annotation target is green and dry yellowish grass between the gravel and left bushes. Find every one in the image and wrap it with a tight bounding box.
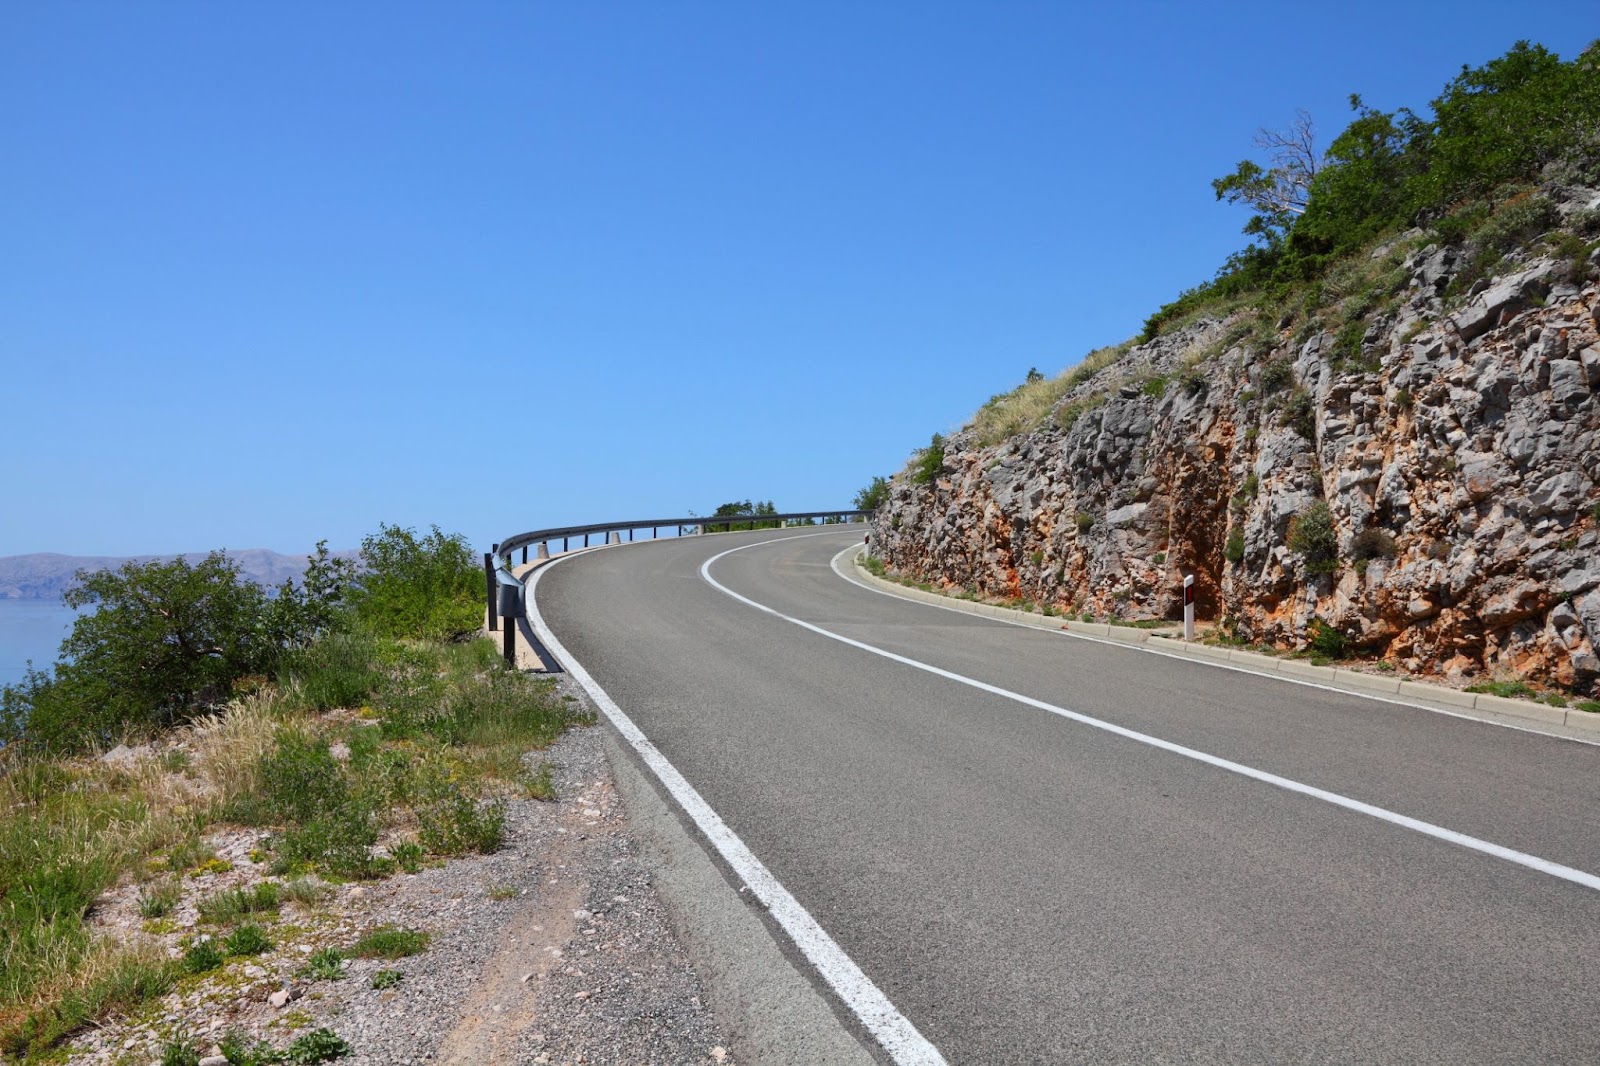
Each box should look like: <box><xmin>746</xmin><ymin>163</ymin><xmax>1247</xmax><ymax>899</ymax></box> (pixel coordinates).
<box><xmin>0</xmin><ymin>630</ymin><xmax>594</xmax><ymax>1061</ymax></box>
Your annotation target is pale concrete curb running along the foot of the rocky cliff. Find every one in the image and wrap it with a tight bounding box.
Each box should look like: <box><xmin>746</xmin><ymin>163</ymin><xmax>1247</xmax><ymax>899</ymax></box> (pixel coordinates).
<box><xmin>851</xmin><ymin>549</ymin><xmax>1600</xmax><ymax>741</ymax></box>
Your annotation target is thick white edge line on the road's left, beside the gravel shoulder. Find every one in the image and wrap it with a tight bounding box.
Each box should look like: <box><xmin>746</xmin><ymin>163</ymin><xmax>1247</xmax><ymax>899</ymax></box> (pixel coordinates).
<box><xmin>525</xmin><ymin>530</ymin><xmax>947</xmax><ymax>1066</ymax></box>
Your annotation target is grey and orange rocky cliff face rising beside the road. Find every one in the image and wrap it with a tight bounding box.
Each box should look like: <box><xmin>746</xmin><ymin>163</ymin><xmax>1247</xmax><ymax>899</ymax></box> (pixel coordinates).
<box><xmin>872</xmin><ymin>187</ymin><xmax>1600</xmax><ymax>695</ymax></box>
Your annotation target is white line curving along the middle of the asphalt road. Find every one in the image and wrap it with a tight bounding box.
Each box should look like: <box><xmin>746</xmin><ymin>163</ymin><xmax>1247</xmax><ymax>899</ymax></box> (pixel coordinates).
<box><xmin>701</xmin><ymin>534</ymin><xmax>1600</xmax><ymax>892</ymax></box>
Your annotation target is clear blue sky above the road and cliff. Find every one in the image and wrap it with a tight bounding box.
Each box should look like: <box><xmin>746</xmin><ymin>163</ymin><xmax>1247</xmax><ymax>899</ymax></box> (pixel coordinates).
<box><xmin>0</xmin><ymin>0</ymin><xmax>1600</xmax><ymax>555</ymax></box>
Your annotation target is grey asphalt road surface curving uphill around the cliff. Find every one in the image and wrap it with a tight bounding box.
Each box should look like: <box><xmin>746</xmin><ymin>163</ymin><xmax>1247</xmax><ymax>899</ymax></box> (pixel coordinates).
<box><xmin>538</xmin><ymin>527</ymin><xmax>1600</xmax><ymax>1066</ymax></box>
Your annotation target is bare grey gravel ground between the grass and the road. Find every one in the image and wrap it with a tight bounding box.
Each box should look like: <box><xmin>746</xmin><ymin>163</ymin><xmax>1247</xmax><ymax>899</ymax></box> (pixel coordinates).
<box><xmin>70</xmin><ymin>679</ymin><xmax>734</xmax><ymax>1066</ymax></box>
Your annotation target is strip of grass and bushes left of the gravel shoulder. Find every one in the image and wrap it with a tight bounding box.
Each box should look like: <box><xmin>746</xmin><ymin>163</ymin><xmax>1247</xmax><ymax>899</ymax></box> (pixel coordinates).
<box><xmin>0</xmin><ymin>528</ymin><xmax>592</xmax><ymax>1061</ymax></box>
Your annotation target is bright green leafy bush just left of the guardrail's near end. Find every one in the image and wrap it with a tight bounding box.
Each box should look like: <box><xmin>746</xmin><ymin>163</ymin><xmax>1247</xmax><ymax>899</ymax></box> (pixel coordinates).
<box><xmin>350</xmin><ymin>525</ymin><xmax>483</xmax><ymax>640</ymax></box>
